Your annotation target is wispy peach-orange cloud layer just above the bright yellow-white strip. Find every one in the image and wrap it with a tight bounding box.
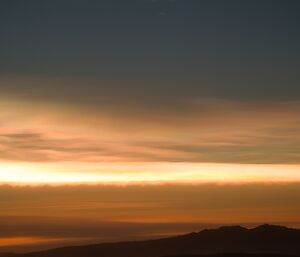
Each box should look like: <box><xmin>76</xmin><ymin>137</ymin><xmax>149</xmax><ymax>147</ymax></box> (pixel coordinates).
<box><xmin>0</xmin><ymin>76</ymin><xmax>300</xmax><ymax>164</ymax></box>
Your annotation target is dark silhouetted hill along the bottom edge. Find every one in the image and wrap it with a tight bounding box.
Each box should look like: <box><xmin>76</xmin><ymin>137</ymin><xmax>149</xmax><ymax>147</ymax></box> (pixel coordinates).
<box><xmin>12</xmin><ymin>225</ymin><xmax>300</xmax><ymax>257</ymax></box>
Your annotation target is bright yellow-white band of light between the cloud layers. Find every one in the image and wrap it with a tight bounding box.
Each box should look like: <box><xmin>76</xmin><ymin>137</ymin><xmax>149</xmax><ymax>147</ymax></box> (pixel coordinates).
<box><xmin>0</xmin><ymin>163</ymin><xmax>300</xmax><ymax>185</ymax></box>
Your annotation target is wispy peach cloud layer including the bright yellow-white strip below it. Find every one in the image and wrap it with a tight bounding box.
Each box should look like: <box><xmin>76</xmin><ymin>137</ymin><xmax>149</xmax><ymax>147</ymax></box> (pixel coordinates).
<box><xmin>0</xmin><ymin>74</ymin><xmax>300</xmax><ymax>184</ymax></box>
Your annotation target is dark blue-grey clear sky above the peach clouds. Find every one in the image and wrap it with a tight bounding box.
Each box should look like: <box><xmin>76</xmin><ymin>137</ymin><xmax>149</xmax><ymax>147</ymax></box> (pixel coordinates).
<box><xmin>0</xmin><ymin>0</ymin><xmax>300</xmax><ymax>102</ymax></box>
